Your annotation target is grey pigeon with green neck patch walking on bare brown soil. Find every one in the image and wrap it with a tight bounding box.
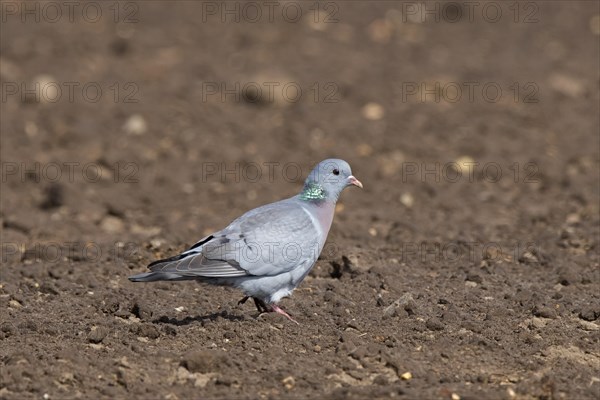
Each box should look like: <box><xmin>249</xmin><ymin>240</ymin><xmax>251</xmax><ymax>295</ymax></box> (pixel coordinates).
<box><xmin>129</xmin><ymin>159</ymin><xmax>362</xmax><ymax>323</ymax></box>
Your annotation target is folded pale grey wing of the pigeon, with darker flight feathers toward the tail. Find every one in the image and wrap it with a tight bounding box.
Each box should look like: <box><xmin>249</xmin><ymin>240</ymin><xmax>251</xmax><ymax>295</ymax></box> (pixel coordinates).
<box><xmin>149</xmin><ymin>200</ymin><xmax>322</xmax><ymax>278</ymax></box>
